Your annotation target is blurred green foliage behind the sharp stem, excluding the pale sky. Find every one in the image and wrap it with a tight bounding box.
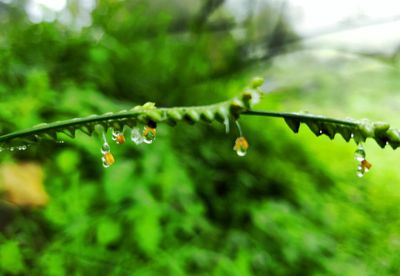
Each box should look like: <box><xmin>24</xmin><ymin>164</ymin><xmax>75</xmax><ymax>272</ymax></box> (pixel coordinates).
<box><xmin>0</xmin><ymin>0</ymin><xmax>400</xmax><ymax>275</ymax></box>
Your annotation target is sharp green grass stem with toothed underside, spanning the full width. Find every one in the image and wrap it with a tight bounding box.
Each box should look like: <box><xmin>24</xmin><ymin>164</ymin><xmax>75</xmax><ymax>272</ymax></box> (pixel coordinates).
<box><xmin>0</xmin><ymin>78</ymin><xmax>400</xmax><ymax>149</ymax></box>
